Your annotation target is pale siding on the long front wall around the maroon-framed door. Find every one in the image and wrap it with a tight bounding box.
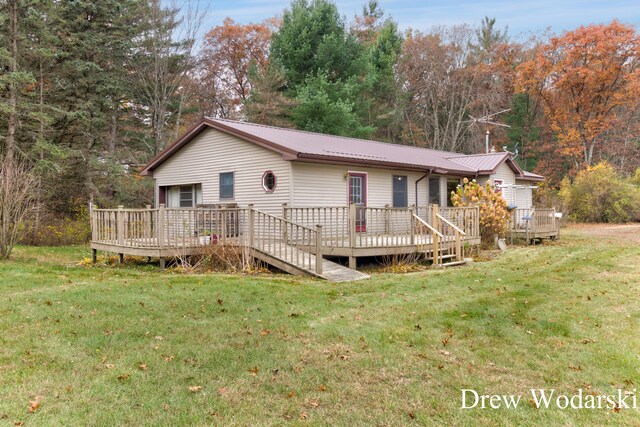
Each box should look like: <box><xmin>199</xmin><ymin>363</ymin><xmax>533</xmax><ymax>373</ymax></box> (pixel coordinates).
<box><xmin>291</xmin><ymin>162</ymin><xmax>427</xmax><ymax>207</ymax></box>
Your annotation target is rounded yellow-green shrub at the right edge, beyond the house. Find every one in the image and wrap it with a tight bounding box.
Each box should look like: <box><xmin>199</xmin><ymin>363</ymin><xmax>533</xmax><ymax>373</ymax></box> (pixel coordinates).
<box><xmin>560</xmin><ymin>162</ymin><xmax>640</xmax><ymax>222</ymax></box>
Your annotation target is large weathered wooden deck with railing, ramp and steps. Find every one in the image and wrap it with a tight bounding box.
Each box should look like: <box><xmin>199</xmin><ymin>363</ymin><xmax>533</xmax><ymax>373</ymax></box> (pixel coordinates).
<box><xmin>90</xmin><ymin>205</ymin><xmax>480</xmax><ymax>281</ymax></box>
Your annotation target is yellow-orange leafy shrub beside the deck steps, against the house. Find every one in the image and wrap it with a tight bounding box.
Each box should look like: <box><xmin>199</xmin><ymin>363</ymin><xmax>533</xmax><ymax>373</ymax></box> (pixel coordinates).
<box><xmin>451</xmin><ymin>178</ymin><xmax>511</xmax><ymax>243</ymax></box>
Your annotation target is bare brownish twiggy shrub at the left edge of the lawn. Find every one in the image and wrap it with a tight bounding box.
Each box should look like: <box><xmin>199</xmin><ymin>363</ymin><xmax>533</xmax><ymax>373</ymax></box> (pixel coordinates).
<box><xmin>0</xmin><ymin>156</ymin><xmax>38</xmax><ymax>259</ymax></box>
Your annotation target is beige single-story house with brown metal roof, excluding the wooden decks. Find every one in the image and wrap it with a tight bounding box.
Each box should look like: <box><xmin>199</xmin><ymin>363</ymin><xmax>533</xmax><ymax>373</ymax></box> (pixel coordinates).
<box><xmin>142</xmin><ymin>118</ymin><xmax>543</xmax><ymax>215</ymax></box>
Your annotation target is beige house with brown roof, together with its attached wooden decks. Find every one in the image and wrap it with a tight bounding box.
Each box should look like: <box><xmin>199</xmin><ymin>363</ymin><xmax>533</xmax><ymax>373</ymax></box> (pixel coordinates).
<box><xmin>90</xmin><ymin>118</ymin><xmax>557</xmax><ymax>281</ymax></box>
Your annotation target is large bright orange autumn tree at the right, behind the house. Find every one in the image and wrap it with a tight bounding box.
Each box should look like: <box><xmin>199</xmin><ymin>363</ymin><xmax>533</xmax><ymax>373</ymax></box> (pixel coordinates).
<box><xmin>517</xmin><ymin>21</ymin><xmax>640</xmax><ymax>169</ymax></box>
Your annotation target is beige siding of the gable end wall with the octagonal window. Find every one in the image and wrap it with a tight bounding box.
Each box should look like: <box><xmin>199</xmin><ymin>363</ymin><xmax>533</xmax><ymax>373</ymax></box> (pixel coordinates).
<box><xmin>153</xmin><ymin>129</ymin><xmax>291</xmax><ymax>215</ymax></box>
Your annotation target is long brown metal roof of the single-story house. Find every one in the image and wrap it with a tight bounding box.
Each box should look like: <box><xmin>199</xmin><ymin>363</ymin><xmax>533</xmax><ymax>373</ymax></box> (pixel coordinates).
<box><xmin>142</xmin><ymin>118</ymin><xmax>544</xmax><ymax>181</ymax></box>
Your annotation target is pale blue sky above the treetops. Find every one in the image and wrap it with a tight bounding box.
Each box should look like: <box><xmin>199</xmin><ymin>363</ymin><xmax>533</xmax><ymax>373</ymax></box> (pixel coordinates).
<box><xmin>195</xmin><ymin>0</ymin><xmax>640</xmax><ymax>37</ymax></box>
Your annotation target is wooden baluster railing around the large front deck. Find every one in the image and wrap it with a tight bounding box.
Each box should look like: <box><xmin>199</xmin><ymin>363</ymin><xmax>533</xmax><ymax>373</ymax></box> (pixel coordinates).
<box><xmin>91</xmin><ymin>205</ymin><xmax>479</xmax><ymax>268</ymax></box>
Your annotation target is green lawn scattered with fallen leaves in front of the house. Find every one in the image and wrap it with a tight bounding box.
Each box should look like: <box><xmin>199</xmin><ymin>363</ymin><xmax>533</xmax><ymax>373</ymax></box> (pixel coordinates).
<box><xmin>0</xmin><ymin>226</ymin><xmax>640</xmax><ymax>426</ymax></box>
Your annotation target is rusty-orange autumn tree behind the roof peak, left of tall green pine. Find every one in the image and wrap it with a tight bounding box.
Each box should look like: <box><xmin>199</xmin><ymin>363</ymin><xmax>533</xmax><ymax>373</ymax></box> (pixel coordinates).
<box><xmin>199</xmin><ymin>18</ymin><xmax>276</xmax><ymax>117</ymax></box>
